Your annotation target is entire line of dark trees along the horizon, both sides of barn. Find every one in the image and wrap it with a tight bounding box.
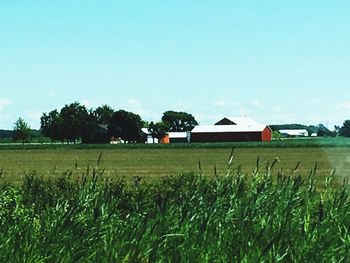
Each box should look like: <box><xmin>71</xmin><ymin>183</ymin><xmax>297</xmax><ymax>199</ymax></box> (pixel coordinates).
<box><xmin>7</xmin><ymin>102</ymin><xmax>350</xmax><ymax>143</ymax></box>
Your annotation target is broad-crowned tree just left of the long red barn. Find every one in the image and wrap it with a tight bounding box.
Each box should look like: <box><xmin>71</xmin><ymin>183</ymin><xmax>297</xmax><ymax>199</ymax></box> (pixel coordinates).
<box><xmin>162</xmin><ymin>111</ymin><xmax>198</xmax><ymax>132</ymax></box>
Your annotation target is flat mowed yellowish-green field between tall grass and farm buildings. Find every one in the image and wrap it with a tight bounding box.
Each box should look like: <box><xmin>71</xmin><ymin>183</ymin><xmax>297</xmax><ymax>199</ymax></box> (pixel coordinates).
<box><xmin>0</xmin><ymin>147</ymin><xmax>350</xmax><ymax>183</ymax></box>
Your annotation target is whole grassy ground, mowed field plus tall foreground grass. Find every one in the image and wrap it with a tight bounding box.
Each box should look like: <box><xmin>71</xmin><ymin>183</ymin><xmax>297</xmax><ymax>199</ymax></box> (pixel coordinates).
<box><xmin>0</xmin><ymin>141</ymin><xmax>350</xmax><ymax>262</ymax></box>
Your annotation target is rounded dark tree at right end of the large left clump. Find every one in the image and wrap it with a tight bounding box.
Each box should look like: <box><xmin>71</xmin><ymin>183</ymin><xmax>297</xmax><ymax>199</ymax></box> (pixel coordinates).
<box><xmin>108</xmin><ymin>110</ymin><xmax>143</xmax><ymax>142</ymax></box>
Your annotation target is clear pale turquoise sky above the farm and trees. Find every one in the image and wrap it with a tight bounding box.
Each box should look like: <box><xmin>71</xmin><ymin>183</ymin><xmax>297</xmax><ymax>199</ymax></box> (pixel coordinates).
<box><xmin>0</xmin><ymin>0</ymin><xmax>350</xmax><ymax>129</ymax></box>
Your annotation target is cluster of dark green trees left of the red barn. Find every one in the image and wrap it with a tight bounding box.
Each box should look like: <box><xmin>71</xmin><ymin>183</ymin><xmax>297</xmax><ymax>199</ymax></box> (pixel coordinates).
<box><xmin>40</xmin><ymin>102</ymin><xmax>198</xmax><ymax>143</ymax></box>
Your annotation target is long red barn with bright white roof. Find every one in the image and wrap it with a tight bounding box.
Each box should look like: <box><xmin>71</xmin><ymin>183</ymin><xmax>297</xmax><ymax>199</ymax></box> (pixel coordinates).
<box><xmin>191</xmin><ymin>117</ymin><xmax>271</xmax><ymax>142</ymax></box>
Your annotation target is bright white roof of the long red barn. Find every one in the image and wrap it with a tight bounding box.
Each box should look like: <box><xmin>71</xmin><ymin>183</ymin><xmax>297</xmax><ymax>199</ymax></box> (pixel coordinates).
<box><xmin>192</xmin><ymin>117</ymin><xmax>267</xmax><ymax>133</ymax></box>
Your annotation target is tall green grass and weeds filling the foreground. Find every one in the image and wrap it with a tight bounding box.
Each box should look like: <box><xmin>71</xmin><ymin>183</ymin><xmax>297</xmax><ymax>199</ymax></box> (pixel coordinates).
<box><xmin>0</xmin><ymin>158</ymin><xmax>350</xmax><ymax>262</ymax></box>
